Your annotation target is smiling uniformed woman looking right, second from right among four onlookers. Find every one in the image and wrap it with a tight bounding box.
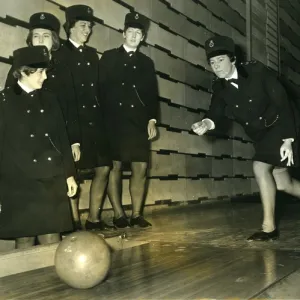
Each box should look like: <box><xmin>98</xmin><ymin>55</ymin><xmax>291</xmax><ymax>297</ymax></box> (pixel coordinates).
<box><xmin>58</xmin><ymin>5</ymin><xmax>115</xmax><ymax>230</ymax></box>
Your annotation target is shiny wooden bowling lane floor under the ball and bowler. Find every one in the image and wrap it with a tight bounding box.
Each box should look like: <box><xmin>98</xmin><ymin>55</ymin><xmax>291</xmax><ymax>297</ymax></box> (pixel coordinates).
<box><xmin>0</xmin><ymin>197</ymin><xmax>300</xmax><ymax>300</ymax></box>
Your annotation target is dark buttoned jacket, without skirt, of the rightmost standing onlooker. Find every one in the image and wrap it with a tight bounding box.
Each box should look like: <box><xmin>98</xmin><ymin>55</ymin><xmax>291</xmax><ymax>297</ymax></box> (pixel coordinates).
<box><xmin>99</xmin><ymin>46</ymin><xmax>158</xmax><ymax>128</ymax></box>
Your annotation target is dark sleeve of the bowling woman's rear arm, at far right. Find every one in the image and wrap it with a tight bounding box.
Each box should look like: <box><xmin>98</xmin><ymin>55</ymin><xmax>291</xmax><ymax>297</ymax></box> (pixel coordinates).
<box><xmin>264</xmin><ymin>68</ymin><xmax>296</xmax><ymax>139</ymax></box>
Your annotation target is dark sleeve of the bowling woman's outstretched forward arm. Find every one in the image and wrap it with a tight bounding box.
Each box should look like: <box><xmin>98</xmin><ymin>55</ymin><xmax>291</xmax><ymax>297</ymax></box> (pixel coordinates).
<box><xmin>204</xmin><ymin>84</ymin><xmax>226</xmax><ymax>129</ymax></box>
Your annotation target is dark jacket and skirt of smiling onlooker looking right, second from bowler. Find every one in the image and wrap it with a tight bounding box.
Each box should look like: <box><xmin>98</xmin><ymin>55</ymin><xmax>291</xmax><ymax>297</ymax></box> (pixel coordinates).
<box><xmin>57</xmin><ymin>40</ymin><xmax>111</xmax><ymax>169</ymax></box>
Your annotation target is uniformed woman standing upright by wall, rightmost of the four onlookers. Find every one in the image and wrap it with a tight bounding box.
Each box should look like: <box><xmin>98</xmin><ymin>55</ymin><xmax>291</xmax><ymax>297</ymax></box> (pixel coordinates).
<box><xmin>99</xmin><ymin>13</ymin><xmax>158</xmax><ymax>228</ymax></box>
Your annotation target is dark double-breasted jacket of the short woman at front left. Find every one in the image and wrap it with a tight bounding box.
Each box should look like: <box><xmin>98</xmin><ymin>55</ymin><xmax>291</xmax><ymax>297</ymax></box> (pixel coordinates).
<box><xmin>0</xmin><ymin>84</ymin><xmax>75</xmax><ymax>178</ymax></box>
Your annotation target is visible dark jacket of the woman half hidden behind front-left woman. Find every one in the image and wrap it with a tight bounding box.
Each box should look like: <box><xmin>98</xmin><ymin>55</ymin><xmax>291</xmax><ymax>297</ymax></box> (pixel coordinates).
<box><xmin>5</xmin><ymin>52</ymin><xmax>80</xmax><ymax>144</ymax></box>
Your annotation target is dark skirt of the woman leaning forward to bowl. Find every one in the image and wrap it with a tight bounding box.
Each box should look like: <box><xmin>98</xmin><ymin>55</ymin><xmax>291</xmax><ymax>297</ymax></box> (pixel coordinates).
<box><xmin>253</xmin><ymin>120</ymin><xmax>299</xmax><ymax>167</ymax></box>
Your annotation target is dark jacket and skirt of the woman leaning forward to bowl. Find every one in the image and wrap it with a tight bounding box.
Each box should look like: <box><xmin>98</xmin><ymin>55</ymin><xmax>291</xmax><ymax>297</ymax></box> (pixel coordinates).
<box><xmin>205</xmin><ymin>61</ymin><xmax>298</xmax><ymax>166</ymax></box>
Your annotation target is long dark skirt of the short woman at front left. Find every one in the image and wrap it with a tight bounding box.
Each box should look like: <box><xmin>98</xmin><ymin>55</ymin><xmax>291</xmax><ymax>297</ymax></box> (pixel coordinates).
<box><xmin>0</xmin><ymin>162</ymin><xmax>73</xmax><ymax>239</ymax></box>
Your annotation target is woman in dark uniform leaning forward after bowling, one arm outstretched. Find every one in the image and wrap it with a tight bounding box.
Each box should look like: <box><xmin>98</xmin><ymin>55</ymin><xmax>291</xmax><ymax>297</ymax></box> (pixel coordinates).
<box><xmin>192</xmin><ymin>36</ymin><xmax>300</xmax><ymax>241</ymax></box>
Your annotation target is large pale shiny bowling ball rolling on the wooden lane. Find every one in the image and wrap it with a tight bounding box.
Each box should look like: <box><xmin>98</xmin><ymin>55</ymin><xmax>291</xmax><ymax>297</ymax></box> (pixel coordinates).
<box><xmin>54</xmin><ymin>231</ymin><xmax>111</xmax><ymax>289</ymax></box>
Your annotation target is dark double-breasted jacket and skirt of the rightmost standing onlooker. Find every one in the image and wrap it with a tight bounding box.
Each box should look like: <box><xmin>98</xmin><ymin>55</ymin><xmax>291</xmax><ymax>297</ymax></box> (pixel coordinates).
<box><xmin>99</xmin><ymin>46</ymin><xmax>158</xmax><ymax>162</ymax></box>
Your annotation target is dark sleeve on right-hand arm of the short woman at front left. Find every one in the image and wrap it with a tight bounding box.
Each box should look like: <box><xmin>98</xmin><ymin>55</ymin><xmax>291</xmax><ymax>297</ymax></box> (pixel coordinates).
<box><xmin>53</xmin><ymin>100</ymin><xmax>76</xmax><ymax>178</ymax></box>
